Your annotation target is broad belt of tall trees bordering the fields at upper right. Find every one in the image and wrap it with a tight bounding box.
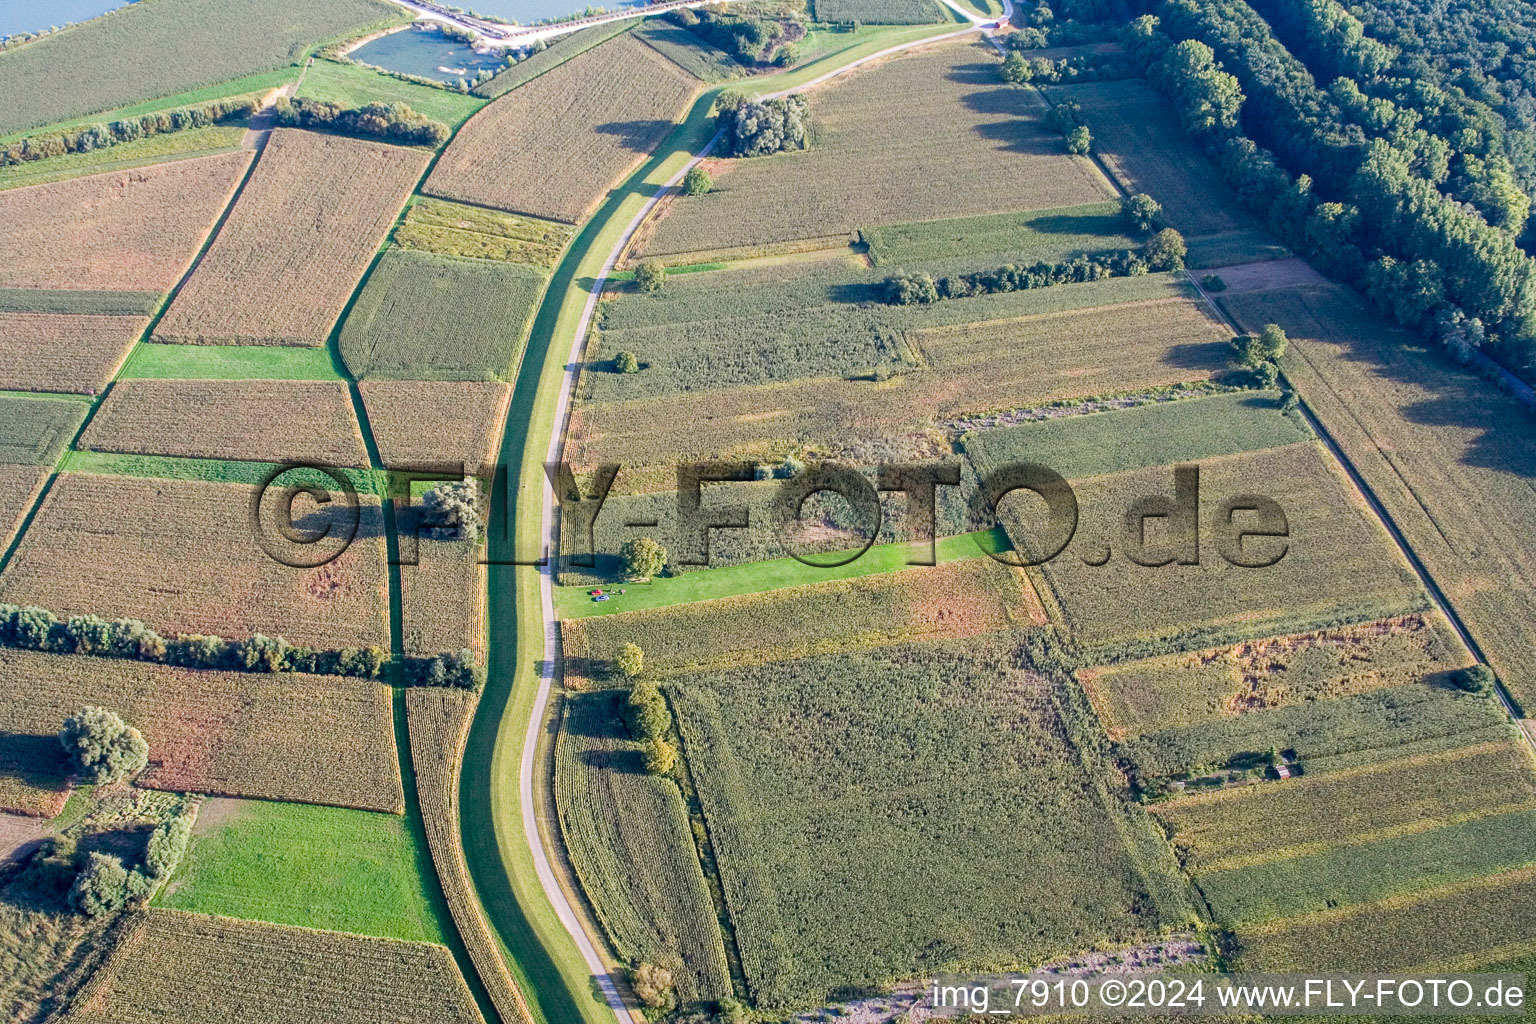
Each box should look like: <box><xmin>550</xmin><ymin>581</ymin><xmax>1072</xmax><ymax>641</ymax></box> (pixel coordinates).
<box><xmin>1126</xmin><ymin>0</ymin><xmax>1536</xmax><ymax>373</ymax></box>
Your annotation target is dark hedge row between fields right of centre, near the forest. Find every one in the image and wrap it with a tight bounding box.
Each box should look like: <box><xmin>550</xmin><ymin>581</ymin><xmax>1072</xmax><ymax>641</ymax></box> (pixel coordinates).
<box><xmin>885</xmin><ymin>234</ymin><xmax>1186</xmax><ymax>306</ymax></box>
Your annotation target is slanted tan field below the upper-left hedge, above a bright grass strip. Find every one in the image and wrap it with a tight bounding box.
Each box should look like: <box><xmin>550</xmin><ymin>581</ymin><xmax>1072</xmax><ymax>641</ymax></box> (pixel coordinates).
<box><xmin>155</xmin><ymin>129</ymin><xmax>432</xmax><ymax>347</ymax></box>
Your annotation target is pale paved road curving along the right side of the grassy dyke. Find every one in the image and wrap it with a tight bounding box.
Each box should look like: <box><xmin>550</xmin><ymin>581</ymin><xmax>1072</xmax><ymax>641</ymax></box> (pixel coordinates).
<box><xmin>518</xmin><ymin>8</ymin><xmax>1012</xmax><ymax>1024</ymax></box>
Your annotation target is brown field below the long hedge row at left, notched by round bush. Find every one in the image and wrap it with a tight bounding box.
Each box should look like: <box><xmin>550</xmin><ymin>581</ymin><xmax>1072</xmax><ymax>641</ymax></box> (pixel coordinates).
<box><xmin>0</xmin><ymin>648</ymin><xmax>404</xmax><ymax>817</ymax></box>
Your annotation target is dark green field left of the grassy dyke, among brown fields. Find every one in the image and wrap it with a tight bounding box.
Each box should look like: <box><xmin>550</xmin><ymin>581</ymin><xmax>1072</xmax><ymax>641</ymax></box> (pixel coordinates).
<box><xmin>339</xmin><ymin>249</ymin><xmax>548</xmax><ymax>381</ymax></box>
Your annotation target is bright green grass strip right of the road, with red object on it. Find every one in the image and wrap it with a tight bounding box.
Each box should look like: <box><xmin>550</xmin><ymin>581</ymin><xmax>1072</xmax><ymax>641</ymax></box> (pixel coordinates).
<box><xmin>554</xmin><ymin>527</ymin><xmax>1012</xmax><ymax>619</ymax></box>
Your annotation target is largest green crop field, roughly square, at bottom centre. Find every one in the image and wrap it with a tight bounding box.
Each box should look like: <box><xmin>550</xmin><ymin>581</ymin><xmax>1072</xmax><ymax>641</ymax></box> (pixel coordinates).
<box><xmin>664</xmin><ymin>642</ymin><xmax>1189</xmax><ymax>1009</ymax></box>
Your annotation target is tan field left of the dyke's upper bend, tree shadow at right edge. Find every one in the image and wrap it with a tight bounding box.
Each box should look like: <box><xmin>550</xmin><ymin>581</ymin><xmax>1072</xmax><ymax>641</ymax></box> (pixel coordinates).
<box><xmin>425</xmin><ymin>34</ymin><xmax>699</xmax><ymax>224</ymax></box>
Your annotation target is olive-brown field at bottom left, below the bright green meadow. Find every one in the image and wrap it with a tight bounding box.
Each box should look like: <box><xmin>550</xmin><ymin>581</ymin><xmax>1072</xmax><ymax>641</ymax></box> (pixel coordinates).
<box><xmin>69</xmin><ymin>909</ymin><xmax>484</xmax><ymax>1024</ymax></box>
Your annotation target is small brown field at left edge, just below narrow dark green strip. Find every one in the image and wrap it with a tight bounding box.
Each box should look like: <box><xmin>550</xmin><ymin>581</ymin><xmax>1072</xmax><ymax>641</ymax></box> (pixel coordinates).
<box><xmin>0</xmin><ymin>313</ymin><xmax>149</xmax><ymax>395</ymax></box>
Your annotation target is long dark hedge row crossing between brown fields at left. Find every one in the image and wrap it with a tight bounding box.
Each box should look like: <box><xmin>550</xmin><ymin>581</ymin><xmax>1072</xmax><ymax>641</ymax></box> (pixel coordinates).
<box><xmin>0</xmin><ymin>605</ymin><xmax>484</xmax><ymax>689</ymax></box>
